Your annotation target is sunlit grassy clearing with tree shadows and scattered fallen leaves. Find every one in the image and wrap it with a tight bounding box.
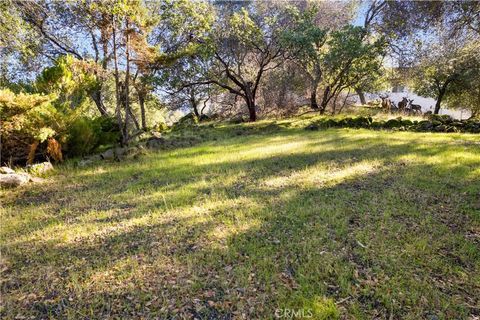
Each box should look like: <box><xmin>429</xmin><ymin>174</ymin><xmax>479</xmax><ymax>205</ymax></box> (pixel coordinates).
<box><xmin>0</xmin><ymin>122</ymin><xmax>480</xmax><ymax>319</ymax></box>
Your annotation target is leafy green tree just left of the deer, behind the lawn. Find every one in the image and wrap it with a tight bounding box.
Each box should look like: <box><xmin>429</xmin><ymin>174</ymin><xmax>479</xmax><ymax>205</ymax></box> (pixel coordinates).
<box><xmin>282</xmin><ymin>6</ymin><xmax>386</xmax><ymax>110</ymax></box>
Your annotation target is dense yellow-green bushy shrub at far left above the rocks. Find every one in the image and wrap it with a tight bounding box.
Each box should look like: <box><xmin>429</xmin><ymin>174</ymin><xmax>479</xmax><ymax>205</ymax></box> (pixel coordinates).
<box><xmin>0</xmin><ymin>56</ymin><xmax>118</xmax><ymax>161</ymax></box>
